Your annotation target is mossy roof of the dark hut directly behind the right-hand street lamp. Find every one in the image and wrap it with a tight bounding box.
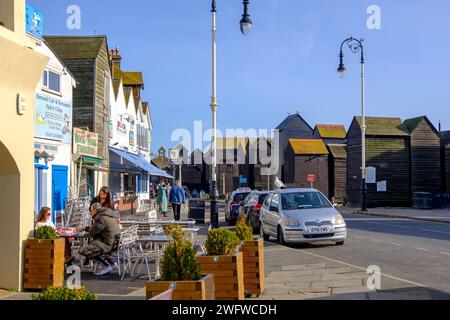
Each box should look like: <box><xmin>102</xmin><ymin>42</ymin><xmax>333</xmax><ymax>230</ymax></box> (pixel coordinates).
<box><xmin>355</xmin><ymin>117</ymin><xmax>409</xmax><ymax>137</ymax></box>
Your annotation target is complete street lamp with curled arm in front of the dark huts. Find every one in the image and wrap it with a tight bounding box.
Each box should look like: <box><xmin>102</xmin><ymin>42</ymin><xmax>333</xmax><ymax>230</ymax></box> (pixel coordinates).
<box><xmin>337</xmin><ymin>37</ymin><xmax>367</xmax><ymax>211</ymax></box>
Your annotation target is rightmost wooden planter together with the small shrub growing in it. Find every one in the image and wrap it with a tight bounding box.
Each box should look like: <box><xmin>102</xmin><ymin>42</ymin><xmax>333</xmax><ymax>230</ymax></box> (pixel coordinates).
<box><xmin>236</xmin><ymin>215</ymin><xmax>264</xmax><ymax>296</ymax></box>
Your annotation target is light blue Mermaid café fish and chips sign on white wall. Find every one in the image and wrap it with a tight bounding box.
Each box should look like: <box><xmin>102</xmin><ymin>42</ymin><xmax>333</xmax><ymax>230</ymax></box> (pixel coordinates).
<box><xmin>34</xmin><ymin>93</ymin><xmax>72</xmax><ymax>144</ymax></box>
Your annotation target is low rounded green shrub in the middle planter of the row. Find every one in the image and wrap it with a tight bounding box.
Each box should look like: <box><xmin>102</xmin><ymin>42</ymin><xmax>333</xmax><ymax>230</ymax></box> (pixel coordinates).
<box><xmin>205</xmin><ymin>229</ymin><xmax>241</xmax><ymax>256</ymax></box>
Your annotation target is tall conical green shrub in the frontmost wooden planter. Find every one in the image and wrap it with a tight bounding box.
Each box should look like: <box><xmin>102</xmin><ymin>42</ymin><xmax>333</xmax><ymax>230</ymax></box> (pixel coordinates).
<box><xmin>161</xmin><ymin>226</ymin><xmax>201</xmax><ymax>281</ymax></box>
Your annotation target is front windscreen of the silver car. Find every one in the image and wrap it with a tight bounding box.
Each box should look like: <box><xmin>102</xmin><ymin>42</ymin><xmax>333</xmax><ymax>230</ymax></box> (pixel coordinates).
<box><xmin>281</xmin><ymin>191</ymin><xmax>331</xmax><ymax>210</ymax></box>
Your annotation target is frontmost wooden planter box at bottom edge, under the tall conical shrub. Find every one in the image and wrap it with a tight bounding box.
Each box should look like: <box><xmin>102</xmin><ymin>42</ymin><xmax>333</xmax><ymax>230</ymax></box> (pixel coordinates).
<box><xmin>145</xmin><ymin>274</ymin><xmax>215</xmax><ymax>300</ymax></box>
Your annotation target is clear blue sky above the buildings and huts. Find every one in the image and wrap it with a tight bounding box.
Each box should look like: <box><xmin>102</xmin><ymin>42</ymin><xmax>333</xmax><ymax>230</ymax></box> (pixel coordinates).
<box><xmin>28</xmin><ymin>0</ymin><xmax>450</xmax><ymax>152</ymax></box>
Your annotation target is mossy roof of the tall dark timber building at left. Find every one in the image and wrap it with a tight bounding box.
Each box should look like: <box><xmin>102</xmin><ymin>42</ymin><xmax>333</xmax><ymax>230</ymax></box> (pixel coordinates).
<box><xmin>44</xmin><ymin>36</ymin><xmax>107</xmax><ymax>60</ymax></box>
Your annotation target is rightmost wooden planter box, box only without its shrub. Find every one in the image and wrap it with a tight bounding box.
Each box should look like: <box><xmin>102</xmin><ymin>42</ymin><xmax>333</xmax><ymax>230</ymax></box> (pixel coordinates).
<box><xmin>240</xmin><ymin>239</ymin><xmax>264</xmax><ymax>296</ymax></box>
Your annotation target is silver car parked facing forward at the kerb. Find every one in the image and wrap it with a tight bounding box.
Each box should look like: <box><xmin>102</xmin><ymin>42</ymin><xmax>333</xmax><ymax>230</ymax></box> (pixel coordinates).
<box><xmin>260</xmin><ymin>189</ymin><xmax>347</xmax><ymax>245</ymax></box>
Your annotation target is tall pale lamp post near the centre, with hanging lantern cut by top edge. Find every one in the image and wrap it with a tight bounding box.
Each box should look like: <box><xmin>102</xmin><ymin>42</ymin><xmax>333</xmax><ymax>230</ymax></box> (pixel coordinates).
<box><xmin>210</xmin><ymin>0</ymin><xmax>252</xmax><ymax>228</ymax></box>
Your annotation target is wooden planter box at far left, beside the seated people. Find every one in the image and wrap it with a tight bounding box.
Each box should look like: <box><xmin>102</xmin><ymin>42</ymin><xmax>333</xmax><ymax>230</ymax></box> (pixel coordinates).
<box><xmin>23</xmin><ymin>238</ymin><xmax>65</xmax><ymax>290</ymax></box>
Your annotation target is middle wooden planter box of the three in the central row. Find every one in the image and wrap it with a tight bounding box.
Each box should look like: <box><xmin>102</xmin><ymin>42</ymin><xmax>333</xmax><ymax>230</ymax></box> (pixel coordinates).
<box><xmin>197</xmin><ymin>252</ymin><xmax>244</xmax><ymax>300</ymax></box>
